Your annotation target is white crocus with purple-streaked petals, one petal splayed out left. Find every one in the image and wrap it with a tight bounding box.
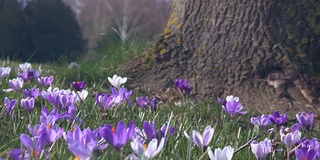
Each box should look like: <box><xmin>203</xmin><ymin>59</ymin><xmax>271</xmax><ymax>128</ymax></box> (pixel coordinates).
<box><xmin>184</xmin><ymin>126</ymin><xmax>214</xmax><ymax>151</ymax></box>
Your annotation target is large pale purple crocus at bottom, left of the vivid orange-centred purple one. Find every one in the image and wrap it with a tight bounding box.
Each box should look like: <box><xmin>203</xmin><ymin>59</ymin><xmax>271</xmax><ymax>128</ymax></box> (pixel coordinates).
<box><xmin>63</xmin><ymin>125</ymin><xmax>98</xmax><ymax>160</ymax></box>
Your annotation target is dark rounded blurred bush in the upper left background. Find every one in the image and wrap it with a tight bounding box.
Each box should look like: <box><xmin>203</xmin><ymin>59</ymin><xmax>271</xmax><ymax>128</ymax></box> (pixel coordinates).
<box><xmin>0</xmin><ymin>0</ymin><xmax>86</xmax><ymax>62</ymax></box>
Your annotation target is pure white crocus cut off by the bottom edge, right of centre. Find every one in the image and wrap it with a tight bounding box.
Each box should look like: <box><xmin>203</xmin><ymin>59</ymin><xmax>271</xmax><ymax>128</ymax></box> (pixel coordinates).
<box><xmin>208</xmin><ymin>146</ymin><xmax>234</xmax><ymax>160</ymax></box>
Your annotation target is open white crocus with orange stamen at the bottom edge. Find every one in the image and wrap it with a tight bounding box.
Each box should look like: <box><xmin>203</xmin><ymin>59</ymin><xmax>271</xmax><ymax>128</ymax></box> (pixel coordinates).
<box><xmin>131</xmin><ymin>138</ymin><xmax>165</xmax><ymax>159</ymax></box>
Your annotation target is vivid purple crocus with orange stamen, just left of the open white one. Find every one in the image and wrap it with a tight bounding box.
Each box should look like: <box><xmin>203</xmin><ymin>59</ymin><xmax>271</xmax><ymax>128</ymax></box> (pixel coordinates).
<box><xmin>99</xmin><ymin>121</ymin><xmax>135</xmax><ymax>151</ymax></box>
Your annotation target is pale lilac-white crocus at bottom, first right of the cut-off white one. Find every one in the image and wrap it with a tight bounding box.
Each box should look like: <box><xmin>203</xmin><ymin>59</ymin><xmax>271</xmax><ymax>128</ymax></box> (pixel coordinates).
<box><xmin>250</xmin><ymin>138</ymin><xmax>272</xmax><ymax>160</ymax></box>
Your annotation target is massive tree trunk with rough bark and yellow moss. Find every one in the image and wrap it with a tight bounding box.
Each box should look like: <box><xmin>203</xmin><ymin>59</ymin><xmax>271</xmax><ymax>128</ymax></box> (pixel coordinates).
<box><xmin>127</xmin><ymin>0</ymin><xmax>320</xmax><ymax>113</ymax></box>
